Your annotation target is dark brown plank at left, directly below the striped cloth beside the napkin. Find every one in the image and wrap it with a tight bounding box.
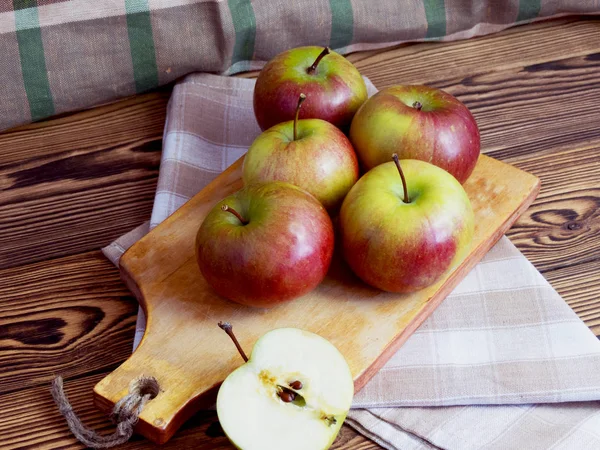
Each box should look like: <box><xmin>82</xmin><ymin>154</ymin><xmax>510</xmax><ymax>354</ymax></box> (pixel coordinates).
<box><xmin>0</xmin><ymin>91</ymin><xmax>168</xmax><ymax>268</ymax></box>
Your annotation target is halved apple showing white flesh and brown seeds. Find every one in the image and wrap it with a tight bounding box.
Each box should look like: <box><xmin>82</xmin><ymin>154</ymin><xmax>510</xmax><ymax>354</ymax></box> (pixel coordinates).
<box><xmin>217</xmin><ymin>328</ymin><xmax>354</xmax><ymax>450</ymax></box>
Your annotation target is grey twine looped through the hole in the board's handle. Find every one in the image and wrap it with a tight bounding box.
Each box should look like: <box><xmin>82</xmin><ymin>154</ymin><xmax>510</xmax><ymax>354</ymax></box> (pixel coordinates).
<box><xmin>51</xmin><ymin>376</ymin><xmax>160</xmax><ymax>448</ymax></box>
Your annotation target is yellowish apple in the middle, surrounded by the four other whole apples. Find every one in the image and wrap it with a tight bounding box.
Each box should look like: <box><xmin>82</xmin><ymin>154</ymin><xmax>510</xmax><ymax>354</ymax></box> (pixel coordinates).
<box><xmin>242</xmin><ymin>119</ymin><xmax>358</xmax><ymax>212</ymax></box>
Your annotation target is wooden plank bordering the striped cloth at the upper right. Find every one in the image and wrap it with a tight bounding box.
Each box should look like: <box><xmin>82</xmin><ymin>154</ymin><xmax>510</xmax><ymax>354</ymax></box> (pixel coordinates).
<box><xmin>348</xmin><ymin>18</ymin><xmax>600</xmax><ymax>88</ymax></box>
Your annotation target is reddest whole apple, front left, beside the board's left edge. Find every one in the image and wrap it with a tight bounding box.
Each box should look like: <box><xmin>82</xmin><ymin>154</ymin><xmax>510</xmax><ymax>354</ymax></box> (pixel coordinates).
<box><xmin>196</xmin><ymin>182</ymin><xmax>334</xmax><ymax>308</ymax></box>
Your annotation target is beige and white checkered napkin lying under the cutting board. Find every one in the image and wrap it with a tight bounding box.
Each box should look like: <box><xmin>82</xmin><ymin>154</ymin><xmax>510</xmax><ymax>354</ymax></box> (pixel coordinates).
<box><xmin>105</xmin><ymin>75</ymin><xmax>600</xmax><ymax>449</ymax></box>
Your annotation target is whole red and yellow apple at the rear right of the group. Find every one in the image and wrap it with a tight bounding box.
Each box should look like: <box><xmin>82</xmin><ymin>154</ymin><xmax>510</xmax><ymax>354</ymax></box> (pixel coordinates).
<box><xmin>350</xmin><ymin>85</ymin><xmax>481</xmax><ymax>184</ymax></box>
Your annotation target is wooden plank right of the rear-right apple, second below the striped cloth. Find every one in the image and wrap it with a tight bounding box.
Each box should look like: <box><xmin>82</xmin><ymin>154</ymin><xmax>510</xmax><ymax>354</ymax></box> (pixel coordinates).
<box><xmin>448</xmin><ymin>53</ymin><xmax>600</xmax><ymax>162</ymax></box>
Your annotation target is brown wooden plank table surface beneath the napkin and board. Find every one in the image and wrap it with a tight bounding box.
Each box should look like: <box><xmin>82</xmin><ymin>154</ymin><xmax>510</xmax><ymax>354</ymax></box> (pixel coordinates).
<box><xmin>0</xmin><ymin>18</ymin><xmax>600</xmax><ymax>450</ymax></box>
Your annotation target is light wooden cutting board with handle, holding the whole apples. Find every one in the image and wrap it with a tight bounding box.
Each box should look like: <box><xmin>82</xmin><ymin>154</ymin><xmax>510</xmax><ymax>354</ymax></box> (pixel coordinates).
<box><xmin>94</xmin><ymin>155</ymin><xmax>540</xmax><ymax>443</ymax></box>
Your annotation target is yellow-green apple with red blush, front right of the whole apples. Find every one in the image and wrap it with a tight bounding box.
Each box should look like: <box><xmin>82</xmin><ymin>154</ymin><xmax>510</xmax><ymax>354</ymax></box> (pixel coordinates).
<box><xmin>340</xmin><ymin>160</ymin><xmax>474</xmax><ymax>293</ymax></box>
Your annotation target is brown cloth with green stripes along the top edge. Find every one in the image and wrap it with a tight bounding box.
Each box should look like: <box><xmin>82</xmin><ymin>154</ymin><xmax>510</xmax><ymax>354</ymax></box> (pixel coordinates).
<box><xmin>0</xmin><ymin>0</ymin><xmax>600</xmax><ymax>130</ymax></box>
